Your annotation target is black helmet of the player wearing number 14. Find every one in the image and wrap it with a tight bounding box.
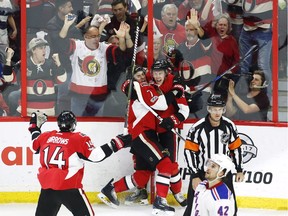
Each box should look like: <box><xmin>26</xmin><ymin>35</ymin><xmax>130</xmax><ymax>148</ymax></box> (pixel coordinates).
<box><xmin>57</xmin><ymin>111</ymin><xmax>77</xmax><ymax>132</ymax></box>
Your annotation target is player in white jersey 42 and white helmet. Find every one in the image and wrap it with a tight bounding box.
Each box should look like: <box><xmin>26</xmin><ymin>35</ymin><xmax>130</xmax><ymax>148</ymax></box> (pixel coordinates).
<box><xmin>191</xmin><ymin>154</ymin><xmax>234</xmax><ymax>216</ymax></box>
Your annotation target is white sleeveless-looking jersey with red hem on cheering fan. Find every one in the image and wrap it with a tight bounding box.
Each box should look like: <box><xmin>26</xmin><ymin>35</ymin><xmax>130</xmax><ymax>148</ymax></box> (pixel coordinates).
<box><xmin>70</xmin><ymin>40</ymin><xmax>109</xmax><ymax>96</ymax></box>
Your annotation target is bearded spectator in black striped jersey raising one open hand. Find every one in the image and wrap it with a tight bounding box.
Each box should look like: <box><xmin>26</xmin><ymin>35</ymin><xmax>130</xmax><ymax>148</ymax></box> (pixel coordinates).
<box><xmin>178</xmin><ymin>9</ymin><xmax>214</xmax><ymax>118</ymax></box>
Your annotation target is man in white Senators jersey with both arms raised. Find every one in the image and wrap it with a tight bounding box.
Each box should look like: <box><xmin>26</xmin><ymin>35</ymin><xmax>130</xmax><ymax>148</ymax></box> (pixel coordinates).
<box><xmin>58</xmin><ymin>15</ymin><xmax>133</xmax><ymax>116</ymax></box>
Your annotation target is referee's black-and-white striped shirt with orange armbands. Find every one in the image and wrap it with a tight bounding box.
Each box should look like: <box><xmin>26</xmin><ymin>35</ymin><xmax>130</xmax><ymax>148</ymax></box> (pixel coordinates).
<box><xmin>184</xmin><ymin>115</ymin><xmax>243</xmax><ymax>178</ymax></box>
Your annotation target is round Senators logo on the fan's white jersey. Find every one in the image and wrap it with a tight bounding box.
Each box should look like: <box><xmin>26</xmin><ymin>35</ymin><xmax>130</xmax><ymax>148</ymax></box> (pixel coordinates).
<box><xmin>78</xmin><ymin>56</ymin><xmax>100</xmax><ymax>77</ymax></box>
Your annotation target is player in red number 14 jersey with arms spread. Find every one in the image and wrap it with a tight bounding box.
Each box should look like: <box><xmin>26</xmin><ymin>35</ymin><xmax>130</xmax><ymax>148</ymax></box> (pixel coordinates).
<box><xmin>29</xmin><ymin>111</ymin><xmax>131</xmax><ymax>216</ymax></box>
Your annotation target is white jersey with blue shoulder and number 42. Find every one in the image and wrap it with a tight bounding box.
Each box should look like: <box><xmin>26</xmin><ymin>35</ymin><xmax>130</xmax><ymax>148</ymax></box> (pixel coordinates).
<box><xmin>191</xmin><ymin>181</ymin><xmax>234</xmax><ymax>216</ymax></box>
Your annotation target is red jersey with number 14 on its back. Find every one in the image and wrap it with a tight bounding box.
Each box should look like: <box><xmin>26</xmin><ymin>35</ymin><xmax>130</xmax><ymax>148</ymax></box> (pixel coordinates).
<box><xmin>32</xmin><ymin>130</ymin><xmax>108</xmax><ymax>190</ymax></box>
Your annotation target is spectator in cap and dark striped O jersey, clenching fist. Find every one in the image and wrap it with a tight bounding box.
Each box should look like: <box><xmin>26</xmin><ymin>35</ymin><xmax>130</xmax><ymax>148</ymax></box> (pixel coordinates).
<box><xmin>17</xmin><ymin>38</ymin><xmax>67</xmax><ymax>116</ymax></box>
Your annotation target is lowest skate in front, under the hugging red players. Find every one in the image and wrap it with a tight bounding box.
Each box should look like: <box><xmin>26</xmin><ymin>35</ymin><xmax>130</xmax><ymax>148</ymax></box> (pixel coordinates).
<box><xmin>152</xmin><ymin>196</ymin><xmax>175</xmax><ymax>216</ymax></box>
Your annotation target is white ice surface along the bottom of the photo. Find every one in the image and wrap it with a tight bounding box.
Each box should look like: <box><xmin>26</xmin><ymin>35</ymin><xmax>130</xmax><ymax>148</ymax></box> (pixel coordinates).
<box><xmin>0</xmin><ymin>204</ymin><xmax>288</xmax><ymax>216</ymax></box>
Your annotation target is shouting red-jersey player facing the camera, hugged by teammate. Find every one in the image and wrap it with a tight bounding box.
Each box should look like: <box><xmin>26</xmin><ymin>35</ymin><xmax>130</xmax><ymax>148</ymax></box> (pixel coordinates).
<box><xmin>151</xmin><ymin>60</ymin><xmax>189</xmax><ymax>206</ymax></box>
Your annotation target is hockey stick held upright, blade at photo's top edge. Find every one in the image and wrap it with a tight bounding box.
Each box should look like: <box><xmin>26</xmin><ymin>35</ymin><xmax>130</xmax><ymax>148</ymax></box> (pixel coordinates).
<box><xmin>123</xmin><ymin>0</ymin><xmax>141</xmax><ymax>134</ymax></box>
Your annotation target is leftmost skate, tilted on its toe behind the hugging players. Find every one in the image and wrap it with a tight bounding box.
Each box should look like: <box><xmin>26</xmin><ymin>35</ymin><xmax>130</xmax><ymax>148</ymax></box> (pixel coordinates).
<box><xmin>98</xmin><ymin>179</ymin><xmax>120</xmax><ymax>208</ymax></box>
